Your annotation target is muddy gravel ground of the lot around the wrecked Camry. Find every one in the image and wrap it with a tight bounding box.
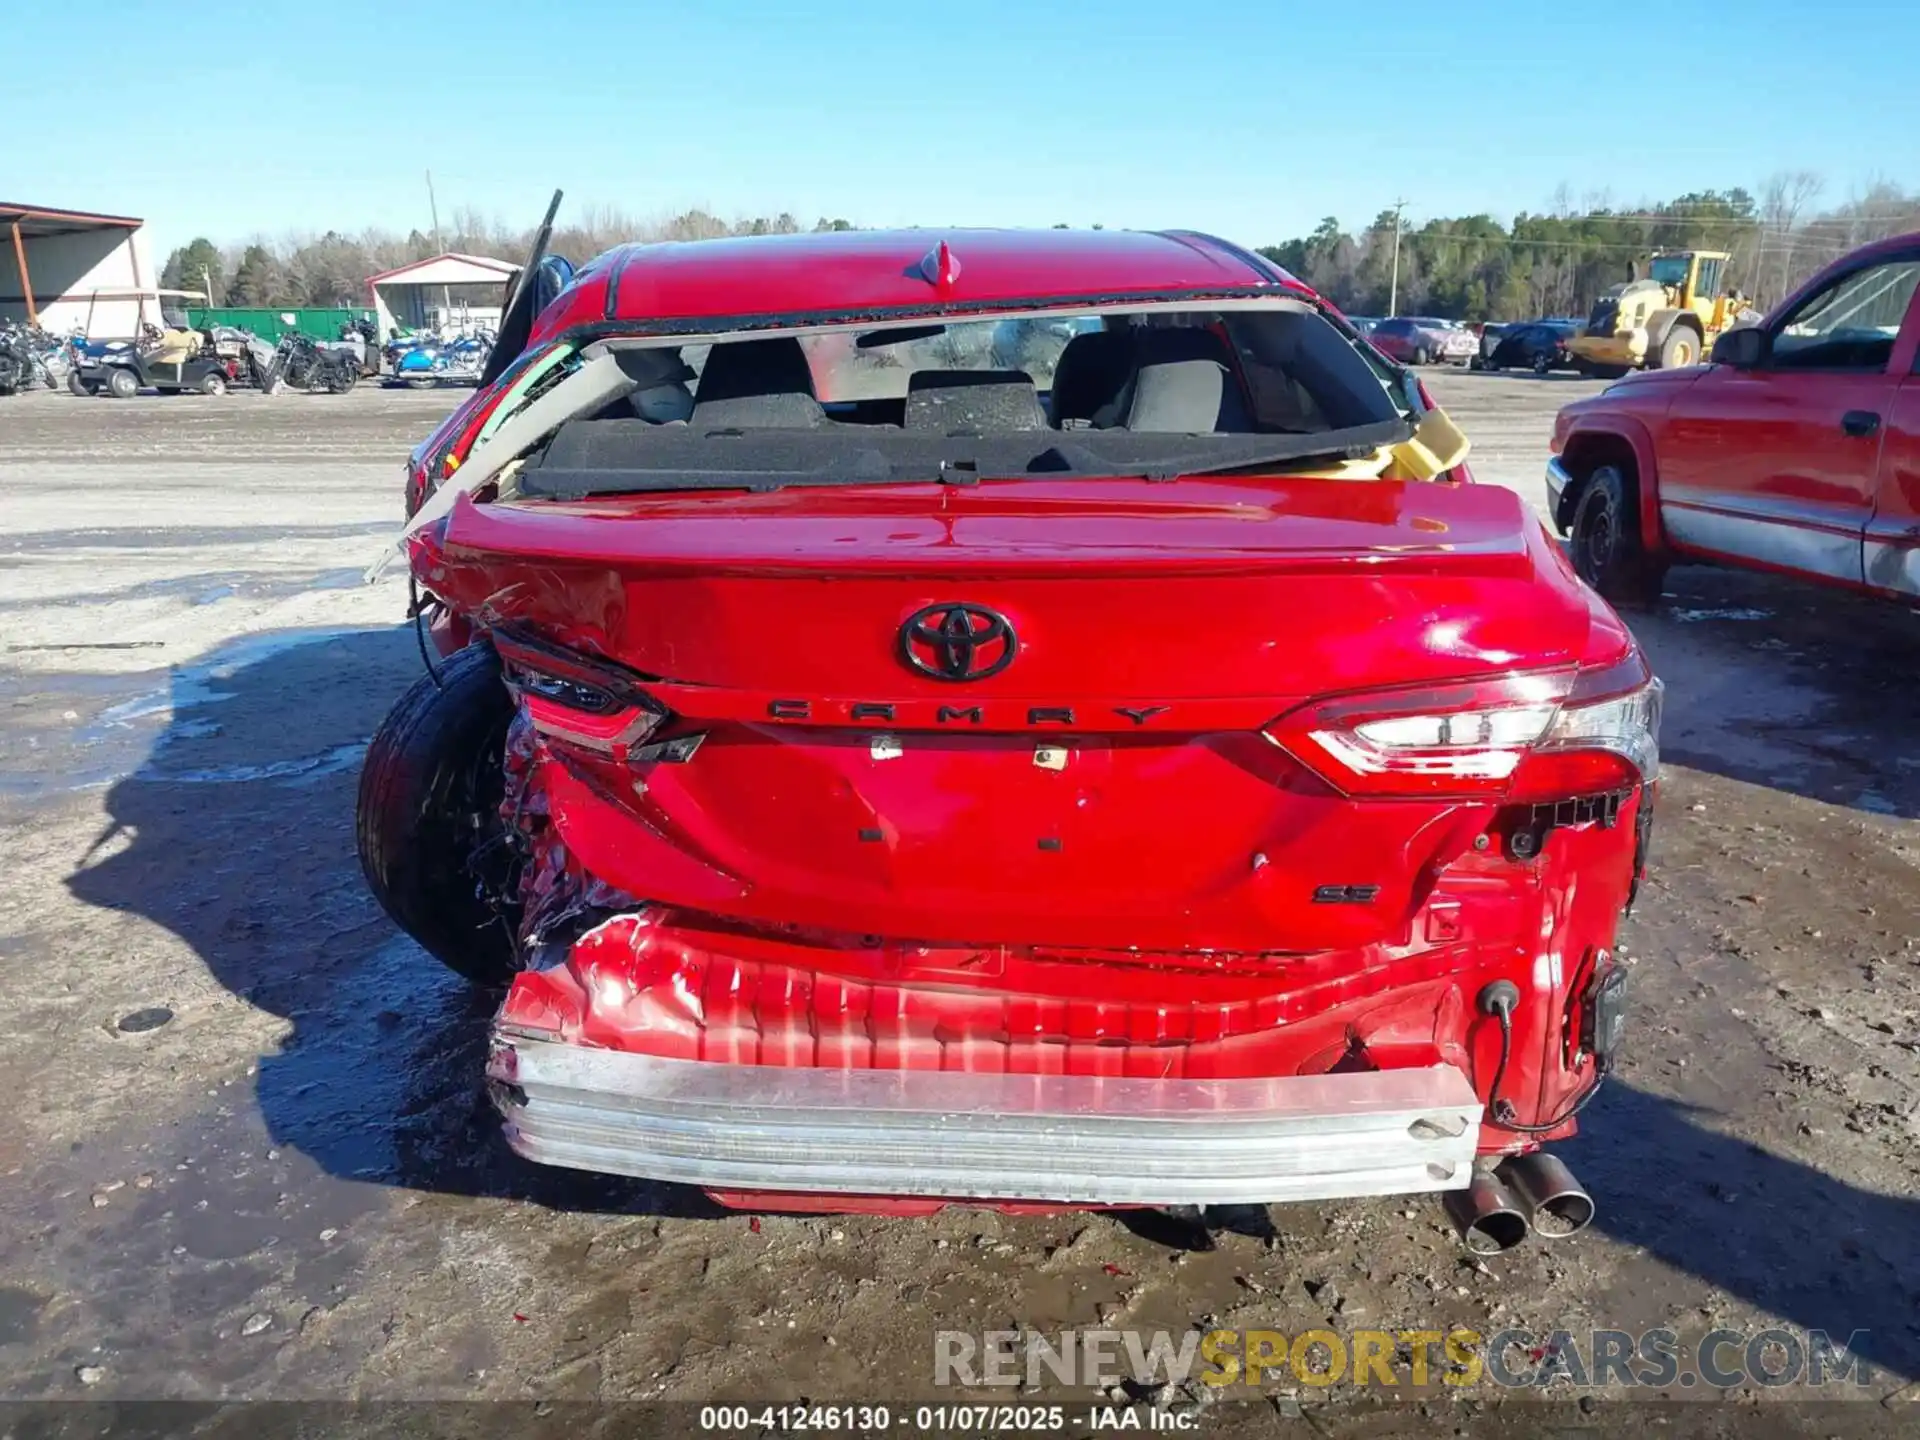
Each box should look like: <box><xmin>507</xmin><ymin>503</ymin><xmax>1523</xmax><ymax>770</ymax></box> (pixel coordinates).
<box><xmin>0</xmin><ymin>374</ymin><xmax>1920</xmax><ymax>1434</ymax></box>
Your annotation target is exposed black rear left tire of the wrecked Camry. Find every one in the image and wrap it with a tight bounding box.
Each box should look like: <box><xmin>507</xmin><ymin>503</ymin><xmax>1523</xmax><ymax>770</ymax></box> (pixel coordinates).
<box><xmin>355</xmin><ymin>645</ymin><xmax>516</xmax><ymax>985</ymax></box>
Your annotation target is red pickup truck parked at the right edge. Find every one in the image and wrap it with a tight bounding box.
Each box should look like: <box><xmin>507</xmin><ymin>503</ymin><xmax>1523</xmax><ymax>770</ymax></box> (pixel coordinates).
<box><xmin>1548</xmin><ymin>234</ymin><xmax>1920</xmax><ymax>603</ymax></box>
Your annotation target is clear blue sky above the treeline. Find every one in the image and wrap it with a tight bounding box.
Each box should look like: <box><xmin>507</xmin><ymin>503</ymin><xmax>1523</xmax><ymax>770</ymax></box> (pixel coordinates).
<box><xmin>0</xmin><ymin>0</ymin><xmax>1920</xmax><ymax>253</ymax></box>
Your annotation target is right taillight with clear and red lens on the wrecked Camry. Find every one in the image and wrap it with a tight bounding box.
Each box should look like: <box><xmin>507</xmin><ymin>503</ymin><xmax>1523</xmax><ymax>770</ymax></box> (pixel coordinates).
<box><xmin>1267</xmin><ymin>651</ymin><xmax>1661</xmax><ymax>801</ymax></box>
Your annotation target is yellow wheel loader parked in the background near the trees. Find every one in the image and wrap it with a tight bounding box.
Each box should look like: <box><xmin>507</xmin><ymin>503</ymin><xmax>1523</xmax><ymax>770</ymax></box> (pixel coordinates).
<box><xmin>1567</xmin><ymin>250</ymin><xmax>1747</xmax><ymax>378</ymax></box>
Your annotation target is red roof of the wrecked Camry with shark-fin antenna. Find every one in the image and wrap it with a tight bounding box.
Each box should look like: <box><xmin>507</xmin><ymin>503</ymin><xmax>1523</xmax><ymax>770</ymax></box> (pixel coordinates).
<box><xmin>534</xmin><ymin>228</ymin><xmax>1313</xmax><ymax>338</ymax></box>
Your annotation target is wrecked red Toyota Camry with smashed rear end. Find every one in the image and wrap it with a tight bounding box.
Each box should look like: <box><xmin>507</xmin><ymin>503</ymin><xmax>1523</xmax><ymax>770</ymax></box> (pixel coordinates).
<box><xmin>359</xmin><ymin>219</ymin><xmax>1661</xmax><ymax>1250</ymax></box>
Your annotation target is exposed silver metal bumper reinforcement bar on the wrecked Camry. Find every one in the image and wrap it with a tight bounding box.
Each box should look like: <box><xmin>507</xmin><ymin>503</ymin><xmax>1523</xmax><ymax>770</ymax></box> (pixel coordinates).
<box><xmin>488</xmin><ymin>1031</ymin><xmax>1482</xmax><ymax>1206</ymax></box>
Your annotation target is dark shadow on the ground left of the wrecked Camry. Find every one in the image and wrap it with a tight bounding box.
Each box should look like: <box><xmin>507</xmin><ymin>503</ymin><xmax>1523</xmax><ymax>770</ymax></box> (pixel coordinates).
<box><xmin>67</xmin><ymin>628</ymin><xmax>712</xmax><ymax>1215</ymax></box>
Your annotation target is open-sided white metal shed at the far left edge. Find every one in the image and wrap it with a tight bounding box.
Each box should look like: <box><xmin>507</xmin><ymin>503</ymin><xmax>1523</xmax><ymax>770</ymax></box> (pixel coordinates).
<box><xmin>0</xmin><ymin>200</ymin><xmax>159</xmax><ymax>340</ymax></box>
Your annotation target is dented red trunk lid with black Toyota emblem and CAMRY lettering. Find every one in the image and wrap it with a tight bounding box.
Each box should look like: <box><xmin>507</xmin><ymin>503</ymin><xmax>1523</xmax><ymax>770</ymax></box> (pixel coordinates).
<box><xmin>419</xmin><ymin>476</ymin><xmax>1624</xmax><ymax>952</ymax></box>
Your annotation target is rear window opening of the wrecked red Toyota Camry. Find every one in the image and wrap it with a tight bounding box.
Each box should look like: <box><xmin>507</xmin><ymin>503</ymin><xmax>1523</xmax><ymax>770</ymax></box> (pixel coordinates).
<box><xmin>520</xmin><ymin>303</ymin><xmax>1411</xmax><ymax>493</ymax></box>
